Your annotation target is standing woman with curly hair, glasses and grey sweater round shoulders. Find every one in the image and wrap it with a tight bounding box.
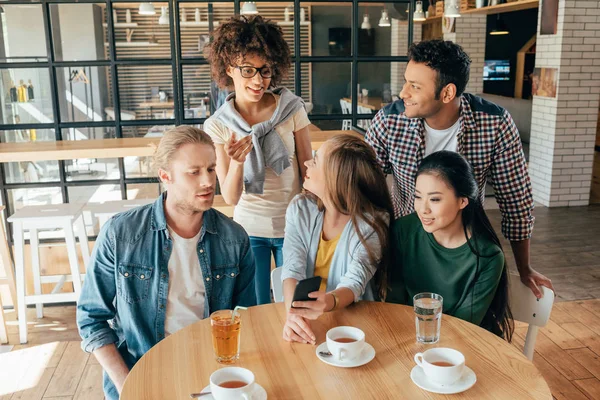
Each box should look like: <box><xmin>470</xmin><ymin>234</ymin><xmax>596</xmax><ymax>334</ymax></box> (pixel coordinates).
<box><xmin>204</xmin><ymin>16</ymin><xmax>312</xmax><ymax>304</ymax></box>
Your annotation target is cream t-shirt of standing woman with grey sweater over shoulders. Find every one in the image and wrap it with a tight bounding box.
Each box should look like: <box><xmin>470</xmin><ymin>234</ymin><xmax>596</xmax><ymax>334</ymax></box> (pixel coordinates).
<box><xmin>204</xmin><ymin>95</ymin><xmax>310</xmax><ymax>238</ymax></box>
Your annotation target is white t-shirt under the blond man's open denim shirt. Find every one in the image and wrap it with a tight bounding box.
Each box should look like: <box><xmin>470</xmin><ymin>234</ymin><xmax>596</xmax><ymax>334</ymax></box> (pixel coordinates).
<box><xmin>165</xmin><ymin>227</ymin><xmax>206</xmax><ymax>335</ymax></box>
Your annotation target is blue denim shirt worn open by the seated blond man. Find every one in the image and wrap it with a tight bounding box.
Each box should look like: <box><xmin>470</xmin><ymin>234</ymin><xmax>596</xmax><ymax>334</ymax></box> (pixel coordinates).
<box><xmin>77</xmin><ymin>194</ymin><xmax>256</xmax><ymax>400</ymax></box>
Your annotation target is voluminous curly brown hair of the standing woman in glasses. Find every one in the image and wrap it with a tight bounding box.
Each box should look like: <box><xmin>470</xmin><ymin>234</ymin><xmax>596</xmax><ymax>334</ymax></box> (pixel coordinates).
<box><xmin>204</xmin><ymin>15</ymin><xmax>292</xmax><ymax>88</ymax></box>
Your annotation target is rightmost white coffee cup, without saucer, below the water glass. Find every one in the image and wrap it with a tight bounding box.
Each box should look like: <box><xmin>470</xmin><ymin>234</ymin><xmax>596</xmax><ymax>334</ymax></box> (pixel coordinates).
<box><xmin>415</xmin><ymin>347</ymin><xmax>465</xmax><ymax>385</ymax></box>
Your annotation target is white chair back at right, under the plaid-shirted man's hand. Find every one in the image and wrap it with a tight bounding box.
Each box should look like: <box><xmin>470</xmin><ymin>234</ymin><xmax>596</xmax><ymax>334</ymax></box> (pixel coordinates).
<box><xmin>508</xmin><ymin>275</ymin><xmax>554</xmax><ymax>360</ymax></box>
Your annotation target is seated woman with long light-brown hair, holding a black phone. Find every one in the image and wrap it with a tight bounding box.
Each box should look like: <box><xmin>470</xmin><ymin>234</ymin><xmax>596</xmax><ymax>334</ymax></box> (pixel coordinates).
<box><xmin>282</xmin><ymin>135</ymin><xmax>393</xmax><ymax>344</ymax></box>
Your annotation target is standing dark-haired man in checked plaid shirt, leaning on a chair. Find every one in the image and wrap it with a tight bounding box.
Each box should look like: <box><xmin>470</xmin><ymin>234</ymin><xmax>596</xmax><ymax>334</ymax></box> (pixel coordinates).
<box><xmin>365</xmin><ymin>40</ymin><xmax>552</xmax><ymax>298</ymax></box>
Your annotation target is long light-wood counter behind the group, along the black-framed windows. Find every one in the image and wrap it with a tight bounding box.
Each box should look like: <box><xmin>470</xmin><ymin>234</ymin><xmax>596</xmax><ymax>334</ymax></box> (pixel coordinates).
<box><xmin>0</xmin><ymin>130</ymin><xmax>363</xmax><ymax>163</ymax></box>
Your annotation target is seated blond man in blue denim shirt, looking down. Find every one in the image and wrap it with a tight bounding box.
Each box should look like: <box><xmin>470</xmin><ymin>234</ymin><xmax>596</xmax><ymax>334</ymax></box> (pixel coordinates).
<box><xmin>77</xmin><ymin>126</ymin><xmax>256</xmax><ymax>400</ymax></box>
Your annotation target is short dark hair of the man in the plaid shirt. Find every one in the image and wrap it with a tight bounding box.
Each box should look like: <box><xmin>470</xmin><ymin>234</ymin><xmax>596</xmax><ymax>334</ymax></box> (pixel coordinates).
<box><xmin>408</xmin><ymin>40</ymin><xmax>471</xmax><ymax>99</ymax></box>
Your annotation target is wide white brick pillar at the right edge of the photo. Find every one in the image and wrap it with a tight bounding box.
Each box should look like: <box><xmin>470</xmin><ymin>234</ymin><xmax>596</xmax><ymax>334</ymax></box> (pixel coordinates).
<box><xmin>529</xmin><ymin>0</ymin><xmax>600</xmax><ymax>207</ymax></box>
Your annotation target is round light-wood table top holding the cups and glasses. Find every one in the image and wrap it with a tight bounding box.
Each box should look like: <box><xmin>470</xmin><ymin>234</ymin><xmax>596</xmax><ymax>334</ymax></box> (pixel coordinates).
<box><xmin>121</xmin><ymin>301</ymin><xmax>552</xmax><ymax>400</ymax></box>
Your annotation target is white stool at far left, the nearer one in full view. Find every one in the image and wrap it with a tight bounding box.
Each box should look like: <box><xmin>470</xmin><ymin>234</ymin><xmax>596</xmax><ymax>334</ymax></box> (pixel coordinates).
<box><xmin>8</xmin><ymin>204</ymin><xmax>90</xmax><ymax>343</ymax></box>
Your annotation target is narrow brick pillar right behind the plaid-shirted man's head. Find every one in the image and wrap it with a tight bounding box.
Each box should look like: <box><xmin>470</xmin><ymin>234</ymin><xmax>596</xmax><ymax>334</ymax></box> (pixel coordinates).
<box><xmin>444</xmin><ymin>14</ymin><xmax>487</xmax><ymax>94</ymax></box>
